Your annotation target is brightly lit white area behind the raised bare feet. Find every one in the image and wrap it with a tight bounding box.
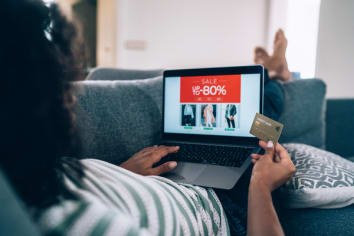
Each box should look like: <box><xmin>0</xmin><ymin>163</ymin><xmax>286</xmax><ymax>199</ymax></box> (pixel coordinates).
<box><xmin>267</xmin><ymin>0</ymin><xmax>321</xmax><ymax>78</ymax></box>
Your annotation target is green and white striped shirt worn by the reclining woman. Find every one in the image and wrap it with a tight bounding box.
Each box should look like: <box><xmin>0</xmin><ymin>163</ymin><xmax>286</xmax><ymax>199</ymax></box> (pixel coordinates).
<box><xmin>38</xmin><ymin>159</ymin><xmax>230</xmax><ymax>236</ymax></box>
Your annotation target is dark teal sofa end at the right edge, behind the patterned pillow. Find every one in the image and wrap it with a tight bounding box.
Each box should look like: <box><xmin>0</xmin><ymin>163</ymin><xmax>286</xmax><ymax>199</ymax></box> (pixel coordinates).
<box><xmin>326</xmin><ymin>99</ymin><xmax>354</xmax><ymax>157</ymax></box>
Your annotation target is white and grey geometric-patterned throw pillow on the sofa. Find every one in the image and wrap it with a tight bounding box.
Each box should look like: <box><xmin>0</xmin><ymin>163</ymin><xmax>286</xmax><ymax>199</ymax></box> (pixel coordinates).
<box><xmin>280</xmin><ymin>144</ymin><xmax>354</xmax><ymax>208</ymax></box>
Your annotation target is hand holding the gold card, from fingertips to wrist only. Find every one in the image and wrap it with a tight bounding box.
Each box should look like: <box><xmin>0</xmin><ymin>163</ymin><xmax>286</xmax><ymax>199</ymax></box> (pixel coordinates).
<box><xmin>251</xmin><ymin>141</ymin><xmax>296</xmax><ymax>192</ymax></box>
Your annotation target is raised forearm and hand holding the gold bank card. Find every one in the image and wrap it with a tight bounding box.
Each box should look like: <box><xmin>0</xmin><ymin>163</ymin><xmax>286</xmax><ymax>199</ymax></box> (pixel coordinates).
<box><xmin>247</xmin><ymin>141</ymin><xmax>296</xmax><ymax>236</ymax></box>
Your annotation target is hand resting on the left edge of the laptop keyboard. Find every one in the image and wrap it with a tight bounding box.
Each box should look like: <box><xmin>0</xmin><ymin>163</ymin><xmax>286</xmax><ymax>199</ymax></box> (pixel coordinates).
<box><xmin>120</xmin><ymin>145</ymin><xmax>179</xmax><ymax>175</ymax></box>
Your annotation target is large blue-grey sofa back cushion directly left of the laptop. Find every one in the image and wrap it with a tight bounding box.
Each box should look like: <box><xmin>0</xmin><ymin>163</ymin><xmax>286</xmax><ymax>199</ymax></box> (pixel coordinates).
<box><xmin>75</xmin><ymin>77</ymin><xmax>162</xmax><ymax>164</ymax></box>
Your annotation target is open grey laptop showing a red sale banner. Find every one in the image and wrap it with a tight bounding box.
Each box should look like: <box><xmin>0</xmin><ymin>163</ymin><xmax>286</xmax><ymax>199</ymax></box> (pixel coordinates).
<box><xmin>160</xmin><ymin>65</ymin><xmax>264</xmax><ymax>189</ymax></box>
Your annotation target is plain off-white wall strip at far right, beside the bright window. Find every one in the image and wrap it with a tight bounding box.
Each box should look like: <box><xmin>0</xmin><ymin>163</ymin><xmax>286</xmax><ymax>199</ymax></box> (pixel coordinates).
<box><xmin>316</xmin><ymin>0</ymin><xmax>354</xmax><ymax>97</ymax></box>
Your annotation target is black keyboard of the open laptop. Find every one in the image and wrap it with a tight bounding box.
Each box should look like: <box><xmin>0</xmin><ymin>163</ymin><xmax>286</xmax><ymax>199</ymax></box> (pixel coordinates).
<box><xmin>158</xmin><ymin>143</ymin><xmax>253</xmax><ymax>167</ymax></box>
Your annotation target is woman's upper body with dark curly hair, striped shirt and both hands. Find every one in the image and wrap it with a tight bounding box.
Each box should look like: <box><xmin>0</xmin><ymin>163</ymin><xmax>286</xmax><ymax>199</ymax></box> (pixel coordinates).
<box><xmin>0</xmin><ymin>0</ymin><xmax>294</xmax><ymax>235</ymax></box>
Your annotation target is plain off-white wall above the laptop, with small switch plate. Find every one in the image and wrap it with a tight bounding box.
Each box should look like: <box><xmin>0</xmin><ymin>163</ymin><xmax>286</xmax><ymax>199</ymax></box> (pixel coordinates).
<box><xmin>117</xmin><ymin>0</ymin><xmax>268</xmax><ymax>68</ymax></box>
